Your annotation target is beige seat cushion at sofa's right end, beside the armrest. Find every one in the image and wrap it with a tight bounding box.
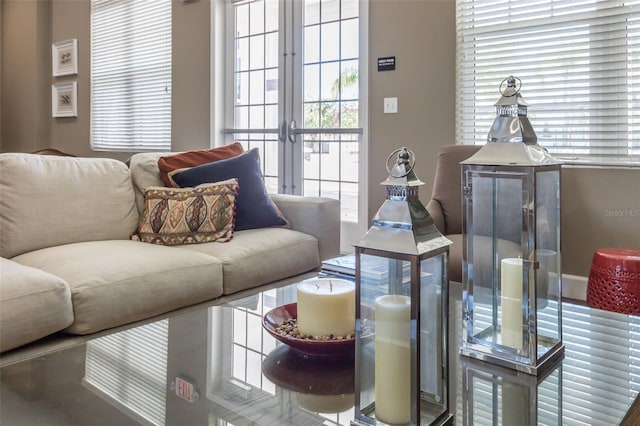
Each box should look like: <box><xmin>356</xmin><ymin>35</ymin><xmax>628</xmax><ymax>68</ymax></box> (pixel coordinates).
<box><xmin>184</xmin><ymin>228</ymin><xmax>320</xmax><ymax>294</ymax></box>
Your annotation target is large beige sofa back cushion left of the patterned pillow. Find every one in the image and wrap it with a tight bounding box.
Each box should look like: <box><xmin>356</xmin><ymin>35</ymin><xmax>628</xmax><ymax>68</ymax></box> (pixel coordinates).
<box><xmin>0</xmin><ymin>153</ymin><xmax>139</xmax><ymax>258</ymax></box>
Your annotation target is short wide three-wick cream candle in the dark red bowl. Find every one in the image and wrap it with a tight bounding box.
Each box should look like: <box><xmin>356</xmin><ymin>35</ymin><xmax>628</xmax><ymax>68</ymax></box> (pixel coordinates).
<box><xmin>297</xmin><ymin>279</ymin><xmax>356</xmax><ymax>337</ymax></box>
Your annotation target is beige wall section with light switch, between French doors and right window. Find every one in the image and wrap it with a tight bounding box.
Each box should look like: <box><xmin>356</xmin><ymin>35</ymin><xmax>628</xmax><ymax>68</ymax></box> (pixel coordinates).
<box><xmin>368</xmin><ymin>0</ymin><xmax>456</xmax><ymax>217</ymax></box>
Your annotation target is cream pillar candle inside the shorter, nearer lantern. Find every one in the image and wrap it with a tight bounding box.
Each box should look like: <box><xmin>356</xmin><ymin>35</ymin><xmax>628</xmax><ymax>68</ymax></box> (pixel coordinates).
<box><xmin>375</xmin><ymin>295</ymin><xmax>411</xmax><ymax>424</ymax></box>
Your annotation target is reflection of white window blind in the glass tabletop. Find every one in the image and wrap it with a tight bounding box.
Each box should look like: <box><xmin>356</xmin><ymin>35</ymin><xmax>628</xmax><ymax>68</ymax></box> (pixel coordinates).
<box><xmin>82</xmin><ymin>320</ymin><xmax>169</xmax><ymax>425</ymax></box>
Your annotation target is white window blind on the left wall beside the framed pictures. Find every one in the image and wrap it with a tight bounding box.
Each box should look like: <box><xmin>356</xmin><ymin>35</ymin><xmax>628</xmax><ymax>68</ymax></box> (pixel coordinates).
<box><xmin>91</xmin><ymin>0</ymin><xmax>171</xmax><ymax>152</ymax></box>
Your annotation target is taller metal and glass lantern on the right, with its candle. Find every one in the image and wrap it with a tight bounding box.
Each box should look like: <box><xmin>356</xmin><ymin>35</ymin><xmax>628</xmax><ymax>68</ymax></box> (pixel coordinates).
<box><xmin>460</xmin><ymin>77</ymin><xmax>564</xmax><ymax>374</ymax></box>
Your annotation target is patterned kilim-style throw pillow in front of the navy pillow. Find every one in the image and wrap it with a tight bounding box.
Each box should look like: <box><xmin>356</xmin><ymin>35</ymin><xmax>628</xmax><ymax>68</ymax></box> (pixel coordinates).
<box><xmin>132</xmin><ymin>179</ymin><xmax>239</xmax><ymax>245</ymax></box>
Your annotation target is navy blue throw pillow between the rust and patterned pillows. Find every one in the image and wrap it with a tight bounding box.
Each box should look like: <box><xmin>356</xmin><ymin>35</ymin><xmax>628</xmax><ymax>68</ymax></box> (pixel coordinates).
<box><xmin>169</xmin><ymin>148</ymin><xmax>287</xmax><ymax>231</ymax></box>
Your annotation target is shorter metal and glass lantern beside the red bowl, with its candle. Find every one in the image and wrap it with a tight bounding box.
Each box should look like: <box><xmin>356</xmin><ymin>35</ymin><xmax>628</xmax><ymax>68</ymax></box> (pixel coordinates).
<box><xmin>351</xmin><ymin>147</ymin><xmax>453</xmax><ymax>425</ymax></box>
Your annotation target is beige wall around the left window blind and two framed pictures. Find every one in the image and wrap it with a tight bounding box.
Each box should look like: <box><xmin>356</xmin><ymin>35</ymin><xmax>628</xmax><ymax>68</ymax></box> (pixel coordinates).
<box><xmin>0</xmin><ymin>0</ymin><xmax>210</xmax><ymax>160</ymax></box>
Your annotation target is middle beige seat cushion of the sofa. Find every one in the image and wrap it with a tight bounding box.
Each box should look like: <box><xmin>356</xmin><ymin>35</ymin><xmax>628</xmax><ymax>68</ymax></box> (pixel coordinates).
<box><xmin>14</xmin><ymin>240</ymin><xmax>222</xmax><ymax>334</ymax></box>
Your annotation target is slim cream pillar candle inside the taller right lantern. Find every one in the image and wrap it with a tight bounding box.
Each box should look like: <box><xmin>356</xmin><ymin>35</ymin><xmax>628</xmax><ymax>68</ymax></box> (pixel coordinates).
<box><xmin>500</xmin><ymin>258</ymin><xmax>522</xmax><ymax>349</ymax></box>
